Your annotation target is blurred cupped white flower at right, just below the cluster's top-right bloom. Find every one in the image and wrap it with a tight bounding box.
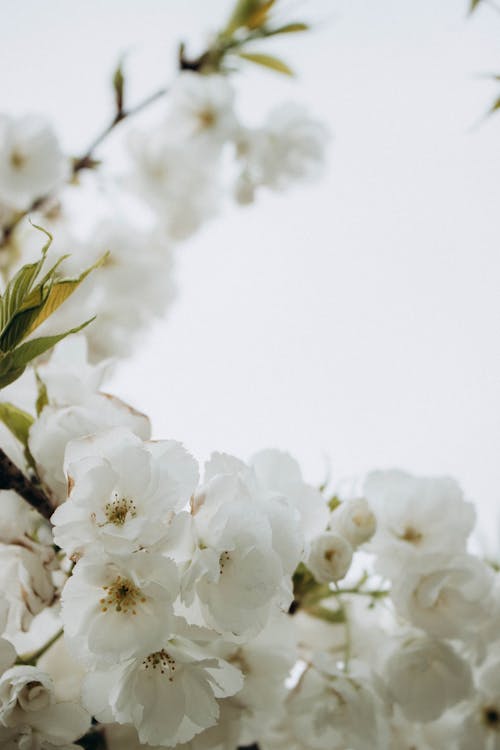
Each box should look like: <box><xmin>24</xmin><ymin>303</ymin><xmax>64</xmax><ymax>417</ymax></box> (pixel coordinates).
<box><xmin>391</xmin><ymin>554</ymin><xmax>493</xmax><ymax>639</ymax></box>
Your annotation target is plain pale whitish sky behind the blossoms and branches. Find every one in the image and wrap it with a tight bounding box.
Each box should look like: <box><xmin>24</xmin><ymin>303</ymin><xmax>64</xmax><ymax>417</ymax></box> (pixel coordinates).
<box><xmin>0</xmin><ymin>0</ymin><xmax>500</xmax><ymax>540</ymax></box>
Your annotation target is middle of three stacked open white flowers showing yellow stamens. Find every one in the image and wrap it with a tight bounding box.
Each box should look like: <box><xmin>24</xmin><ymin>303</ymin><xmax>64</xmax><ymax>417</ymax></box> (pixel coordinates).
<box><xmin>61</xmin><ymin>550</ymin><xmax>179</xmax><ymax>663</ymax></box>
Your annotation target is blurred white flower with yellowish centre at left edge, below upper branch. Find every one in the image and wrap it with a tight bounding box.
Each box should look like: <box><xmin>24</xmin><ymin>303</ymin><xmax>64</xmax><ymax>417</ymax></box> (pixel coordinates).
<box><xmin>0</xmin><ymin>115</ymin><xmax>68</xmax><ymax>211</ymax></box>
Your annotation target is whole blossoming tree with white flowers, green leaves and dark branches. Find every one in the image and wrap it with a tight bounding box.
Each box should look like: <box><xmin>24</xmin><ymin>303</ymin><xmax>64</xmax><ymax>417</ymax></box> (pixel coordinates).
<box><xmin>0</xmin><ymin>0</ymin><xmax>500</xmax><ymax>750</ymax></box>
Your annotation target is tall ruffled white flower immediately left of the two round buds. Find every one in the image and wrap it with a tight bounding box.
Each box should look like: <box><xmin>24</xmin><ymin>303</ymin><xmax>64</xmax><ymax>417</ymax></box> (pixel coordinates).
<box><xmin>182</xmin><ymin>454</ymin><xmax>304</xmax><ymax>635</ymax></box>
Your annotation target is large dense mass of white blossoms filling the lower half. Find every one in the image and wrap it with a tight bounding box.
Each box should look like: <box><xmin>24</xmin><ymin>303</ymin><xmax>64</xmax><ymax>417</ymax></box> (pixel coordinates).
<box><xmin>0</xmin><ymin>337</ymin><xmax>500</xmax><ymax>750</ymax></box>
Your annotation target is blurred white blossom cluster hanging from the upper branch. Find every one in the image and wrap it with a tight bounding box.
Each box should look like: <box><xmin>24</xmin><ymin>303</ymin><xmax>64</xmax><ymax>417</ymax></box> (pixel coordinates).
<box><xmin>0</xmin><ymin>71</ymin><xmax>328</xmax><ymax>361</ymax></box>
